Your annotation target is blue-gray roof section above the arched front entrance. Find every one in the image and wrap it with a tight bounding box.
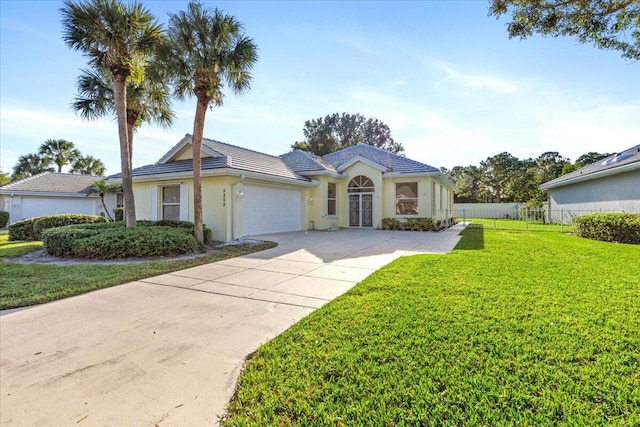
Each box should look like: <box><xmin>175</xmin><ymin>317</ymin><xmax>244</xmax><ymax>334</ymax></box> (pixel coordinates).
<box><xmin>322</xmin><ymin>144</ymin><xmax>440</xmax><ymax>173</ymax></box>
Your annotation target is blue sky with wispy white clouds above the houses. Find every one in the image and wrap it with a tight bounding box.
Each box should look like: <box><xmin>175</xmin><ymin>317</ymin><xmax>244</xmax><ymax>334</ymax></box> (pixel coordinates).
<box><xmin>0</xmin><ymin>0</ymin><xmax>640</xmax><ymax>173</ymax></box>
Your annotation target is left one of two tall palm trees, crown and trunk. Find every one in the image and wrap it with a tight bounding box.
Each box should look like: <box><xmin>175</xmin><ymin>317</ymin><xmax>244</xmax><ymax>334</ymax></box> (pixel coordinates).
<box><xmin>60</xmin><ymin>0</ymin><xmax>164</xmax><ymax>227</ymax></box>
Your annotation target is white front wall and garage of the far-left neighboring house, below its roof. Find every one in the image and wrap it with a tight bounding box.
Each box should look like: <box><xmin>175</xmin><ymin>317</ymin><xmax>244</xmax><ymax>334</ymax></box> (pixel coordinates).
<box><xmin>0</xmin><ymin>194</ymin><xmax>109</xmax><ymax>224</ymax></box>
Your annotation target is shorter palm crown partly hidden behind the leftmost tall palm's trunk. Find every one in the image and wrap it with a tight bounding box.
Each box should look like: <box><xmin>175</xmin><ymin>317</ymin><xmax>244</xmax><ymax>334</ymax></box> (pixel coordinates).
<box><xmin>71</xmin><ymin>64</ymin><xmax>175</xmax><ymax>169</ymax></box>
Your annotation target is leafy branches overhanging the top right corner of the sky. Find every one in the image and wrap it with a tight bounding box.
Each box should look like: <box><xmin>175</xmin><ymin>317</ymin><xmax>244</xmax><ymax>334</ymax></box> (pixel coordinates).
<box><xmin>489</xmin><ymin>0</ymin><xmax>640</xmax><ymax>61</ymax></box>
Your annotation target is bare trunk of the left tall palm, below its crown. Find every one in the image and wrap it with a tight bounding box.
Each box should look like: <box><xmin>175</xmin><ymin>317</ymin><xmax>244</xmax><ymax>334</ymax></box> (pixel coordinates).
<box><xmin>113</xmin><ymin>75</ymin><xmax>136</xmax><ymax>227</ymax></box>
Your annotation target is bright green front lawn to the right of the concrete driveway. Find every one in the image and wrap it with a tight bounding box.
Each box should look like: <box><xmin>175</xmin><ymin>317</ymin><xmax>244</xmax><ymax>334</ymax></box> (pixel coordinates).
<box><xmin>223</xmin><ymin>229</ymin><xmax>640</xmax><ymax>426</ymax></box>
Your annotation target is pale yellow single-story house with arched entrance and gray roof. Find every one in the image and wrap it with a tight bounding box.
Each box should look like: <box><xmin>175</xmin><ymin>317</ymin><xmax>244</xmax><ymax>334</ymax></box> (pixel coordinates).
<box><xmin>109</xmin><ymin>135</ymin><xmax>455</xmax><ymax>241</ymax></box>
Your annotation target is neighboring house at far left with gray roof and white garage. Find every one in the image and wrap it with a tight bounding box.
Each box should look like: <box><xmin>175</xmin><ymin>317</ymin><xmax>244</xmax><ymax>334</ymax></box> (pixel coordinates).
<box><xmin>0</xmin><ymin>172</ymin><xmax>116</xmax><ymax>224</ymax></box>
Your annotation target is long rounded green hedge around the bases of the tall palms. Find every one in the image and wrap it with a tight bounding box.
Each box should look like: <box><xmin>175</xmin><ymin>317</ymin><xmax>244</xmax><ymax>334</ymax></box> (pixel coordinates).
<box><xmin>42</xmin><ymin>223</ymin><xmax>198</xmax><ymax>259</ymax></box>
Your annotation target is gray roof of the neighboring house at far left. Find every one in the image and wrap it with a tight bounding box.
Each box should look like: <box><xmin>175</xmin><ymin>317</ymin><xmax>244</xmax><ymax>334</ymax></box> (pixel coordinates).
<box><xmin>0</xmin><ymin>172</ymin><xmax>103</xmax><ymax>194</ymax></box>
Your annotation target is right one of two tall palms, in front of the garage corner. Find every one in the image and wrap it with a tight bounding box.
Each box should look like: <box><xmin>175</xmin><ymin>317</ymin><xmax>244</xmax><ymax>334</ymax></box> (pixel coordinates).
<box><xmin>161</xmin><ymin>2</ymin><xmax>258</xmax><ymax>245</ymax></box>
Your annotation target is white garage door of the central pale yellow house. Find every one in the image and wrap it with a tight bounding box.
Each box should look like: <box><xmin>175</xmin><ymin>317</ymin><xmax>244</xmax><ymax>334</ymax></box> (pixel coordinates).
<box><xmin>242</xmin><ymin>184</ymin><xmax>302</xmax><ymax>236</ymax></box>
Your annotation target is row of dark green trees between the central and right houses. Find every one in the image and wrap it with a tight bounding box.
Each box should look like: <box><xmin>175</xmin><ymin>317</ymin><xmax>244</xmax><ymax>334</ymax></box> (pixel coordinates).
<box><xmin>442</xmin><ymin>151</ymin><xmax>612</xmax><ymax>207</ymax></box>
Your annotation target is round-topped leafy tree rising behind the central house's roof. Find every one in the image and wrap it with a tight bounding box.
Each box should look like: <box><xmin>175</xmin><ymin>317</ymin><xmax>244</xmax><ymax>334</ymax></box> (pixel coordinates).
<box><xmin>291</xmin><ymin>113</ymin><xmax>404</xmax><ymax>156</ymax></box>
